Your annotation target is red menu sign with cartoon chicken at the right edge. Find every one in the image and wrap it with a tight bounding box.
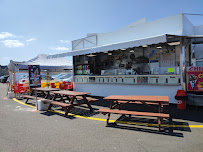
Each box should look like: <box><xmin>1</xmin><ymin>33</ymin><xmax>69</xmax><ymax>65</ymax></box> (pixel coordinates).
<box><xmin>186</xmin><ymin>67</ymin><xmax>203</xmax><ymax>92</ymax></box>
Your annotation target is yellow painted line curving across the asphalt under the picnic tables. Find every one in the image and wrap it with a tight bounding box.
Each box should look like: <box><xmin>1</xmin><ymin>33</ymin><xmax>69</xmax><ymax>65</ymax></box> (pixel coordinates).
<box><xmin>13</xmin><ymin>98</ymin><xmax>203</xmax><ymax>128</ymax></box>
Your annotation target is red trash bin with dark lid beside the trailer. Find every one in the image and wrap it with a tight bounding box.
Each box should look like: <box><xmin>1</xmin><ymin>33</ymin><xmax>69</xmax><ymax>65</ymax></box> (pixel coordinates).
<box><xmin>175</xmin><ymin>90</ymin><xmax>187</xmax><ymax>110</ymax></box>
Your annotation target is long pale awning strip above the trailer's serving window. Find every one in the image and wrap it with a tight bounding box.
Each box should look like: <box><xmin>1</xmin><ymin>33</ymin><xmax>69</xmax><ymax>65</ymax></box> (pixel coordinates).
<box><xmin>47</xmin><ymin>35</ymin><xmax>167</xmax><ymax>59</ymax></box>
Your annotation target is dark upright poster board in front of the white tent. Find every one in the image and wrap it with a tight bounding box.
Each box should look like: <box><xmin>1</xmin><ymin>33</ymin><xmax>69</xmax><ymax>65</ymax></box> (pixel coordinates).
<box><xmin>28</xmin><ymin>65</ymin><xmax>41</xmax><ymax>88</ymax></box>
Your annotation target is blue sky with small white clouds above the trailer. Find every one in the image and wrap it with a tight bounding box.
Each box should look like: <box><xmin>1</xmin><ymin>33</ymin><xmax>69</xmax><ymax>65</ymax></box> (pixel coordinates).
<box><xmin>0</xmin><ymin>0</ymin><xmax>203</xmax><ymax>65</ymax></box>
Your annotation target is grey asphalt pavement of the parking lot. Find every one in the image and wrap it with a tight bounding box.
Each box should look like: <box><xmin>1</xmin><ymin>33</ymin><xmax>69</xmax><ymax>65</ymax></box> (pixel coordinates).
<box><xmin>0</xmin><ymin>84</ymin><xmax>203</xmax><ymax>152</ymax></box>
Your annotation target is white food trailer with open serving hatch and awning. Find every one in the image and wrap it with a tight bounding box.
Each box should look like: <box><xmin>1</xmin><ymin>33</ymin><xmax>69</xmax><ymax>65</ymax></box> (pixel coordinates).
<box><xmin>49</xmin><ymin>14</ymin><xmax>203</xmax><ymax>103</ymax></box>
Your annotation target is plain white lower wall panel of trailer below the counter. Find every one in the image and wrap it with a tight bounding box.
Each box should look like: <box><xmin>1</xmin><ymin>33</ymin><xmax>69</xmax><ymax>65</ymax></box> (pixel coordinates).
<box><xmin>74</xmin><ymin>83</ymin><xmax>181</xmax><ymax>103</ymax></box>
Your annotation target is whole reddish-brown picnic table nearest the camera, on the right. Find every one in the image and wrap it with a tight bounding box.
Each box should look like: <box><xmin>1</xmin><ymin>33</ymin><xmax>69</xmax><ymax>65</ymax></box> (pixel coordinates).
<box><xmin>98</xmin><ymin>95</ymin><xmax>170</xmax><ymax>131</ymax></box>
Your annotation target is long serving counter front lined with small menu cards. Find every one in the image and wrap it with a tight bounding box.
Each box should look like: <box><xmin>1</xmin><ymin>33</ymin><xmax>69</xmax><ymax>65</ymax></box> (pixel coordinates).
<box><xmin>74</xmin><ymin>75</ymin><xmax>181</xmax><ymax>85</ymax></box>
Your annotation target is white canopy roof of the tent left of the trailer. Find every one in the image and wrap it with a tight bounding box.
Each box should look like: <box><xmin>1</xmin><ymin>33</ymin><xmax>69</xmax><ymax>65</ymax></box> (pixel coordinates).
<box><xmin>18</xmin><ymin>54</ymin><xmax>73</xmax><ymax>69</ymax></box>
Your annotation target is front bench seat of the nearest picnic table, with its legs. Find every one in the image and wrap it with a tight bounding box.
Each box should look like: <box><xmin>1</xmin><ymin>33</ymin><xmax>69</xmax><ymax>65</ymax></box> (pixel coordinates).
<box><xmin>98</xmin><ymin>109</ymin><xmax>170</xmax><ymax>131</ymax></box>
